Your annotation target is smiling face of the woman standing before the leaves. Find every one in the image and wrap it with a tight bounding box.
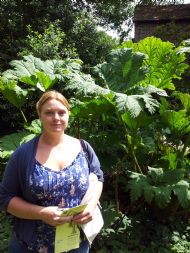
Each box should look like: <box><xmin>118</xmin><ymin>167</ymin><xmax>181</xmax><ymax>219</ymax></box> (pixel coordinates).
<box><xmin>40</xmin><ymin>99</ymin><xmax>69</xmax><ymax>133</ymax></box>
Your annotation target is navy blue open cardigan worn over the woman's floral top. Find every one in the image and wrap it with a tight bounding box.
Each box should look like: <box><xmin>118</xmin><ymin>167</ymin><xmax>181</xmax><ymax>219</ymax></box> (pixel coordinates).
<box><xmin>0</xmin><ymin>136</ymin><xmax>103</xmax><ymax>244</ymax></box>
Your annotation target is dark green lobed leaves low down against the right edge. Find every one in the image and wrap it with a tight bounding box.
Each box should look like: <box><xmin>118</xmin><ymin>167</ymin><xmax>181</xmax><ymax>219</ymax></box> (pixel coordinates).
<box><xmin>127</xmin><ymin>167</ymin><xmax>190</xmax><ymax>208</ymax></box>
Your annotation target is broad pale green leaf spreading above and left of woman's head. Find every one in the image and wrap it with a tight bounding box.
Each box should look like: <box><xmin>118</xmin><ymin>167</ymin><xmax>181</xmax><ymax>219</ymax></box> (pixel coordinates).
<box><xmin>2</xmin><ymin>55</ymin><xmax>81</xmax><ymax>91</ymax></box>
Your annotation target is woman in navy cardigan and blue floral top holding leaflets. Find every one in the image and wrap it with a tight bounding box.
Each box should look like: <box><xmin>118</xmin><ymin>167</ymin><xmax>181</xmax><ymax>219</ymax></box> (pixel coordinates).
<box><xmin>0</xmin><ymin>91</ymin><xmax>103</xmax><ymax>253</ymax></box>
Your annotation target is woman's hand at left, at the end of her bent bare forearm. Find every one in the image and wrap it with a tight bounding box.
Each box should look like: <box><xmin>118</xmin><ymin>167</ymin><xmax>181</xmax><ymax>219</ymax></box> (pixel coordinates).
<box><xmin>40</xmin><ymin>206</ymin><xmax>73</xmax><ymax>226</ymax></box>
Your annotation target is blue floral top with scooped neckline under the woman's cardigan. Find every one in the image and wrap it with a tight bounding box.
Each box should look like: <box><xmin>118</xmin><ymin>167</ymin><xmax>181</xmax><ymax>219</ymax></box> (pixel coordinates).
<box><xmin>28</xmin><ymin>150</ymin><xmax>89</xmax><ymax>252</ymax></box>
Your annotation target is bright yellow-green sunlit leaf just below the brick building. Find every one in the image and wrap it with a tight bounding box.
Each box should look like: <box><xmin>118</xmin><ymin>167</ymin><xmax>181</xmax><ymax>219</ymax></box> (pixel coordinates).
<box><xmin>121</xmin><ymin>37</ymin><xmax>188</xmax><ymax>90</ymax></box>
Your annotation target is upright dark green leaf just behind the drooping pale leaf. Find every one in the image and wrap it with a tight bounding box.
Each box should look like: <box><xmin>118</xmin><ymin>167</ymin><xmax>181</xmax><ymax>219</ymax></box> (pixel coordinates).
<box><xmin>95</xmin><ymin>48</ymin><xmax>148</xmax><ymax>92</ymax></box>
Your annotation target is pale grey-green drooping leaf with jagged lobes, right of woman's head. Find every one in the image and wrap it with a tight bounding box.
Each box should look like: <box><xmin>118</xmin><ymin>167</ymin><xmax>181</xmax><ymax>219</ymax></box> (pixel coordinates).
<box><xmin>65</xmin><ymin>68</ymin><xmax>162</xmax><ymax>118</ymax></box>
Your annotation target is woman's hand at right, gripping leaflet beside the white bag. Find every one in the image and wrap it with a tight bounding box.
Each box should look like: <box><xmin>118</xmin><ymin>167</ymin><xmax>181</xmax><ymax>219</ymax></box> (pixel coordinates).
<box><xmin>72</xmin><ymin>206</ymin><xmax>94</xmax><ymax>225</ymax></box>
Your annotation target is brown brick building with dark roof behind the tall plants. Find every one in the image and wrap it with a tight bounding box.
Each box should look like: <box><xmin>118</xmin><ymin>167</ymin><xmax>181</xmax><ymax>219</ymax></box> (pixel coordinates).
<box><xmin>133</xmin><ymin>4</ymin><xmax>190</xmax><ymax>42</ymax></box>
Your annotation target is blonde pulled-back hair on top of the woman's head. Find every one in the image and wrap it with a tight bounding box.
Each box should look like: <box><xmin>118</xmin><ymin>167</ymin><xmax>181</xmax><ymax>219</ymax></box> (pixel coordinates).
<box><xmin>36</xmin><ymin>90</ymin><xmax>70</xmax><ymax>116</ymax></box>
